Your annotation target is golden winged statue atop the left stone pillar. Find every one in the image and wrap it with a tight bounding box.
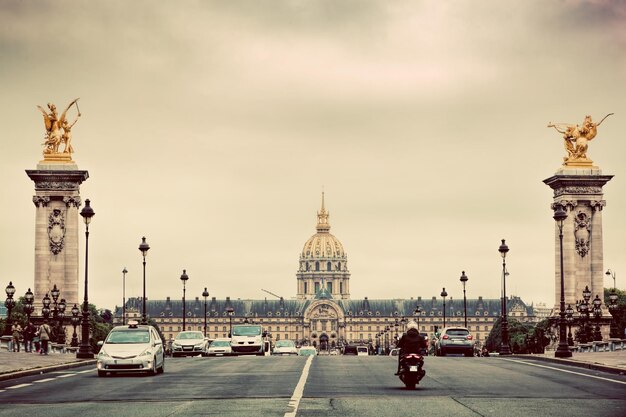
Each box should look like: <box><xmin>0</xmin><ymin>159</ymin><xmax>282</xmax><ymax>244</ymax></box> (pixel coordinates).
<box><xmin>37</xmin><ymin>99</ymin><xmax>80</xmax><ymax>159</ymax></box>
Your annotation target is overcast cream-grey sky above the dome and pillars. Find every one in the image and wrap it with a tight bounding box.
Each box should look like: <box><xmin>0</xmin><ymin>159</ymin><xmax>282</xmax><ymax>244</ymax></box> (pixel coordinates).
<box><xmin>0</xmin><ymin>0</ymin><xmax>626</xmax><ymax>308</ymax></box>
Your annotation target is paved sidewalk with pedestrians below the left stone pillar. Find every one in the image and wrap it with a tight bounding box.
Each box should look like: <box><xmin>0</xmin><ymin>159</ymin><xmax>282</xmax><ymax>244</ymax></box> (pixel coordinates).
<box><xmin>0</xmin><ymin>351</ymin><xmax>95</xmax><ymax>381</ymax></box>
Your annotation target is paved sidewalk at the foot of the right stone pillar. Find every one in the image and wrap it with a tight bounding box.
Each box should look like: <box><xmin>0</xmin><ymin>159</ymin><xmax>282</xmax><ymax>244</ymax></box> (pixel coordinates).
<box><xmin>515</xmin><ymin>350</ymin><xmax>626</xmax><ymax>375</ymax></box>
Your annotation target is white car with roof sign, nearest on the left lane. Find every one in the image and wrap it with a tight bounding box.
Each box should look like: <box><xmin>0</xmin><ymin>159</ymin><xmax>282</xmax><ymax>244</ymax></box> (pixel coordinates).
<box><xmin>96</xmin><ymin>320</ymin><xmax>165</xmax><ymax>377</ymax></box>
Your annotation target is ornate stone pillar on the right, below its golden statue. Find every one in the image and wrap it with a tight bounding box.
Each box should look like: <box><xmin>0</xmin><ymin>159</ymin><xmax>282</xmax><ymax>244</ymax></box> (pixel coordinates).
<box><xmin>544</xmin><ymin>167</ymin><xmax>613</xmax><ymax>313</ymax></box>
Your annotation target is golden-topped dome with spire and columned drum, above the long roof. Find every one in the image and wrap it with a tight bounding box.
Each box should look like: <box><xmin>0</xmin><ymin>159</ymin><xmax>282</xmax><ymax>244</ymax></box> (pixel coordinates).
<box><xmin>296</xmin><ymin>193</ymin><xmax>350</xmax><ymax>300</ymax></box>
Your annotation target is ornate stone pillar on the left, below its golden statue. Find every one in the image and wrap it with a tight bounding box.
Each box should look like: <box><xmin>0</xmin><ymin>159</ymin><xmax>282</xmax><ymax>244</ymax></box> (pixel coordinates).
<box><xmin>26</xmin><ymin>157</ymin><xmax>89</xmax><ymax>311</ymax></box>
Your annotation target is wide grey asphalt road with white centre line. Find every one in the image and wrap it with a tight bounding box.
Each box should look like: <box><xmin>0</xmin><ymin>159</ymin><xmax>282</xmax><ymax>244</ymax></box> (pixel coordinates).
<box><xmin>0</xmin><ymin>356</ymin><xmax>626</xmax><ymax>417</ymax></box>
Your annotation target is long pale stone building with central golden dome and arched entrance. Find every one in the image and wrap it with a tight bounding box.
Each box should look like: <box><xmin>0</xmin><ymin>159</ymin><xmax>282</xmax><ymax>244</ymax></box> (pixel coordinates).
<box><xmin>115</xmin><ymin>195</ymin><xmax>535</xmax><ymax>349</ymax></box>
